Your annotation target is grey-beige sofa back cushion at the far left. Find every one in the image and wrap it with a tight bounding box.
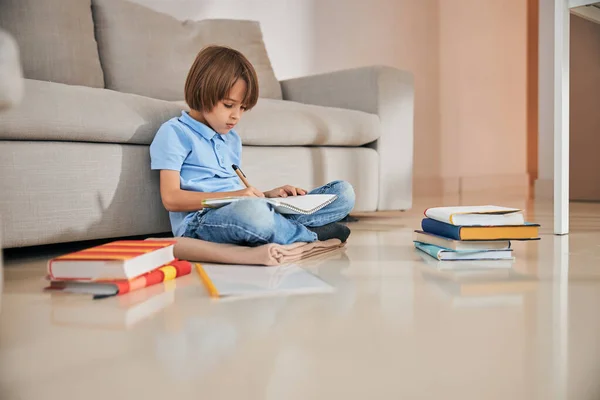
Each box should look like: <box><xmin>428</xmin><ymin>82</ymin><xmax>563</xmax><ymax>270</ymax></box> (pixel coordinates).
<box><xmin>0</xmin><ymin>0</ymin><xmax>104</xmax><ymax>87</ymax></box>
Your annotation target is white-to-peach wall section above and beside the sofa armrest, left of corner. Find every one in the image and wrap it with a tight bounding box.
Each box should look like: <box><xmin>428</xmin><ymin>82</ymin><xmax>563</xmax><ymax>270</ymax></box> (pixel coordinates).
<box><xmin>310</xmin><ymin>0</ymin><xmax>441</xmax><ymax>188</ymax></box>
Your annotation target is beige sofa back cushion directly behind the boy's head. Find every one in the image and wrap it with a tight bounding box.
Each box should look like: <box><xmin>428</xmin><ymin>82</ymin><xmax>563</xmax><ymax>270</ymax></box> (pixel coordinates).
<box><xmin>92</xmin><ymin>0</ymin><xmax>281</xmax><ymax>100</ymax></box>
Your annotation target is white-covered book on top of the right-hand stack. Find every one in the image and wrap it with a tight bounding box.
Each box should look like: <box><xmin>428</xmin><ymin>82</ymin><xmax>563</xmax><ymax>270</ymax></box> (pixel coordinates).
<box><xmin>425</xmin><ymin>206</ymin><xmax>525</xmax><ymax>226</ymax></box>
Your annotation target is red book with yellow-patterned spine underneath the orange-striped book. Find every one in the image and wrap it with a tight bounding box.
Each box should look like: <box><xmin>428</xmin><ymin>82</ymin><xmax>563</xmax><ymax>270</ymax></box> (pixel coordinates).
<box><xmin>47</xmin><ymin>260</ymin><xmax>192</xmax><ymax>298</ymax></box>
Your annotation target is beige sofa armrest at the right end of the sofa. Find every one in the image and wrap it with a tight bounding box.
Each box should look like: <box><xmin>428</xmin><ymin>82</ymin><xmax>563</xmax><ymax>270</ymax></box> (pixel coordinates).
<box><xmin>281</xmin><ymin>66</ymin><xmax>414</xmax><ymax>210</ymax></box>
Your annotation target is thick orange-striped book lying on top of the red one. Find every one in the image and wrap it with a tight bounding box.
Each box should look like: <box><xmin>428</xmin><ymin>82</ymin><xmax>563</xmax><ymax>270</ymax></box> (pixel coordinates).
<box><xmin>48</xmin><ymin>240</ymin><xmax>175</xmax><ymax>281</ymax></box>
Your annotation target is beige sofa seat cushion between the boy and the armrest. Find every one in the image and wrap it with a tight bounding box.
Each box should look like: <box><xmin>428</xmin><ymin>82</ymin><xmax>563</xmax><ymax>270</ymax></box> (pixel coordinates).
<box><xmin>236</xmin><ymin>99</ymin><xmax>380</xmax><ymax>146</ymax></box>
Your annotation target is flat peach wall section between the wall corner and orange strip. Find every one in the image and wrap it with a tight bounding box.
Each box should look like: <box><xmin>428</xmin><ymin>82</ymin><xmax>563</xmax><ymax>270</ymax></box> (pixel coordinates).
<box><xmin>440</xmin><ymin>0</ymin><xmax>529</xmax><ymax>192</ymax></box>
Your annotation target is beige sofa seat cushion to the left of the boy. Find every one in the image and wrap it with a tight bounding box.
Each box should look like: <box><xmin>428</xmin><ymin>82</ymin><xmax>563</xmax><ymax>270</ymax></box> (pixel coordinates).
<box><xmin>0</xmin><ymin>79</ymin><xmax>181</xmax><ymax>144</ymax></box>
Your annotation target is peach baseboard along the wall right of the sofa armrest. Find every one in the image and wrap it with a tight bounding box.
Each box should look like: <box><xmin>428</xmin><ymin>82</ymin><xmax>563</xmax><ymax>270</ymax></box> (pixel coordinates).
<box><xmin>413</xmin><ymin>174</ymin><xmax>530</xmax><ymax>197</ymax></box>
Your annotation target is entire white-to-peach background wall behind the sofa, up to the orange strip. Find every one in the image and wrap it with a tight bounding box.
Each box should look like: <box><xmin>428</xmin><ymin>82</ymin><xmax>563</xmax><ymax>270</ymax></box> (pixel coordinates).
<box><xmin>135</xmin><ymin>0</ymin><xmax>527</xmax><ymax>200</ymax></box>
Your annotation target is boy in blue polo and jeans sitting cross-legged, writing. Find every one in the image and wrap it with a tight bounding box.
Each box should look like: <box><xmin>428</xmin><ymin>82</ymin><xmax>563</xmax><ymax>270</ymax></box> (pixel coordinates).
<box><xmin>150</xmin><ymin>46</ymin><xmax>354</xmax><ymax>245</ymax></box>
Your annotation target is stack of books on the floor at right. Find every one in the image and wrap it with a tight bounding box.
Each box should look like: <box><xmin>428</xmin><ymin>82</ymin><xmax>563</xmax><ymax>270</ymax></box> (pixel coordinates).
<box><xmin>414</xmin><ymin>206</ymin><xmax>539</xmax><ymax>261</ymax></box>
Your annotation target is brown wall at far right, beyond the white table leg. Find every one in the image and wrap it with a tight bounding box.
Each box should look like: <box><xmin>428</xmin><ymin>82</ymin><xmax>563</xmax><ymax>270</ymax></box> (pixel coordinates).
<box><xmin>569</xmin><ymin>15</ymin><xmax>600</xmax><ymax>201</ymax></box>
